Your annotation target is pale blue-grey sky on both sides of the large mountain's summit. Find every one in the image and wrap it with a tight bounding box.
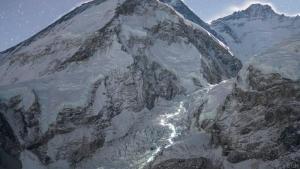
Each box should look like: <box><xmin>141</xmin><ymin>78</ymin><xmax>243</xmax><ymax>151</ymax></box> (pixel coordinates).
<box><xmin>0</xmin><ymin>0</ymin><xmax>300</xmax><ymax>51</ymax></box>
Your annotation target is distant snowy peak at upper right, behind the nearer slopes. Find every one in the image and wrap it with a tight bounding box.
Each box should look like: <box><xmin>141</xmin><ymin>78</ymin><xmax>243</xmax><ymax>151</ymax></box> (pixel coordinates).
<box><xmin>211</xmin><ymin>4</ymin><xmax>300</xmax><ymax>62</ymax></box>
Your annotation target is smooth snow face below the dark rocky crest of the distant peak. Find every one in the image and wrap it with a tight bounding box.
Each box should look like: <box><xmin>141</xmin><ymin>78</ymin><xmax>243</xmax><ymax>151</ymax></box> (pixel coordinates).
<box><xmin>212</xmin><ymin>15</ymin><xmax>300</xmax><ymax>62</ymax></box>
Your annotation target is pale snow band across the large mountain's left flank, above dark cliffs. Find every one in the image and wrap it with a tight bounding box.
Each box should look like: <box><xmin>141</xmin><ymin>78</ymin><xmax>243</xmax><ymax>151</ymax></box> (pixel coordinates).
<box><xmin>1</xmin><ymin>36</ymin><xmax>133</xmax><ymax>132</ymax></box>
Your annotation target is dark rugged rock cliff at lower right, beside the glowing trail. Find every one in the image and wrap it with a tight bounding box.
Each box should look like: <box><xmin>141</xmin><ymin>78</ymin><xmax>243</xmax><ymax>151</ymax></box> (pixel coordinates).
<box><xmin>209</xmin><ymin>66</ymin><xmax>300</xmax><ymax>168</ymax></box>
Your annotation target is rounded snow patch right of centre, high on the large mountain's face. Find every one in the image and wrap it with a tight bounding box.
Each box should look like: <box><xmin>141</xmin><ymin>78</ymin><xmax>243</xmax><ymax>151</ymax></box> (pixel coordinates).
<box><xmin>149</xmin><ymin>40</ymin><xmax>201</xmax><ymax>93</ymax></box>
